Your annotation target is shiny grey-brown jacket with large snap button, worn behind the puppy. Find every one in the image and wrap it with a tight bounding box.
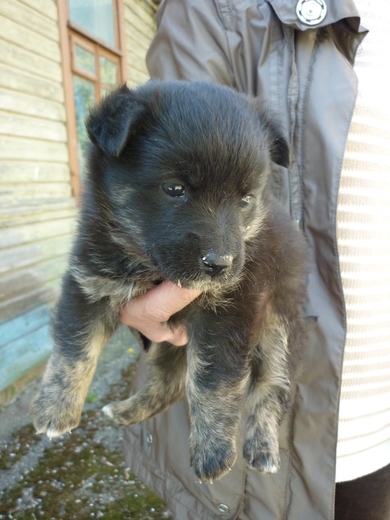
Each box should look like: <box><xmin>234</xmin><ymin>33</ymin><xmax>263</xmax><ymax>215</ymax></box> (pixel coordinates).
<box><xmin>124</xmin><ymin>0</ymin><xmax>365</xmax><ymax>520</ymax></box>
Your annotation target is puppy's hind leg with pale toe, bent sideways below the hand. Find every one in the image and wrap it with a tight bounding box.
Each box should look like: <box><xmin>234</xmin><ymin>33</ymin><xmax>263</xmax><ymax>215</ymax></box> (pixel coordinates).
<box><xmin>103</xmin><ymin>343</ymin><xmax>187</xmax><ymax>424</ymax></box>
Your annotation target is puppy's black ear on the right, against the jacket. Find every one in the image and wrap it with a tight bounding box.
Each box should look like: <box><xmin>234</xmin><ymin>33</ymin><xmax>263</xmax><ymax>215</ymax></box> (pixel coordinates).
<box><xmin>253</xmin><ymin>98</ymin><xmax>290</xmax><ymax>168</ymax></box>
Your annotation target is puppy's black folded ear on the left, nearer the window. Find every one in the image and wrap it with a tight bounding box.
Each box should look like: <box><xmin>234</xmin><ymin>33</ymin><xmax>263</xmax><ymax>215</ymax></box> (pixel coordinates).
<box><xmin>85</xmin><ymin>85</ymin><xmax>146</xmax><ymax>157</ymax></box>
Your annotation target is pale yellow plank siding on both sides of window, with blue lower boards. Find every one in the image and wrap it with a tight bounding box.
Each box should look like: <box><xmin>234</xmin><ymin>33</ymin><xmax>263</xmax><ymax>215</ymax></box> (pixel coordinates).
<box><xmin>0</xmin><ymin>0</ymin><xmax>155</xmax><ymax>403</ymax></box>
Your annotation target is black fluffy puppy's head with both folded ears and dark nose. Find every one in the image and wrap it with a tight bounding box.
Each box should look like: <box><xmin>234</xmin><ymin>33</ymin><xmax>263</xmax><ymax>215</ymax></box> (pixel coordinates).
<box><xmin>87</xmin><ymin>82</ymin><xmax>288</xmax><ymax>290</ymax></box>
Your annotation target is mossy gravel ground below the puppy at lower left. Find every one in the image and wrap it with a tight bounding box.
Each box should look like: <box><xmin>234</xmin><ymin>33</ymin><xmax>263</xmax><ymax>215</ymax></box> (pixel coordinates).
<box><xmin>0</xmin><ymin>327</ymin><xmax>172</xmax><ymax>520</ymax></box>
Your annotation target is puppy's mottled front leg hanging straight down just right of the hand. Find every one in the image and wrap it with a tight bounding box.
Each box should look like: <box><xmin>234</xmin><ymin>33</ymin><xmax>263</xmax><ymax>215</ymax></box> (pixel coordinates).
<box><xmin>186</xmin><ymin>316</ymin><xmax>249</xmax><ymax>482</ymax></box>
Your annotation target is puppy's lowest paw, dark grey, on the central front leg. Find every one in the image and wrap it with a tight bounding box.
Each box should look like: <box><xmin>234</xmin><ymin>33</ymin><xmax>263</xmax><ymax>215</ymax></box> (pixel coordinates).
<box><xmin>190</xmin><ymin>439</ymin><xmax>236</xmax><ymax>483</ymax></box>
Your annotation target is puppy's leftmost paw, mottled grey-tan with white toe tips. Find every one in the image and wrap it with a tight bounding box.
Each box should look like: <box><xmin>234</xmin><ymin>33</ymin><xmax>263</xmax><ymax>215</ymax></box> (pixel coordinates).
<box><xmin>30</xmin><ymin>386</ymin><xmax>83</xmax><ymax>439</ymax></box>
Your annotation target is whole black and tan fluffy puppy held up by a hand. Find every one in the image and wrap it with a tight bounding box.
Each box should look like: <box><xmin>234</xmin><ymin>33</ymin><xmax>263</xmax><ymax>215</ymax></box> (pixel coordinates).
<box><xmin>31</xmin><ymin>81</ymin><xmax>307</xmax><ymax>481</ymax></box>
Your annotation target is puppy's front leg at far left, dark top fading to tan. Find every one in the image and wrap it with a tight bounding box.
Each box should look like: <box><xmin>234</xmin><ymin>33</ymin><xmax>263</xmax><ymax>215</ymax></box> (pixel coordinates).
<box><xmin>30</xmin><ymin>273</ymin><xmax>116</xmax><ymax>437</ymax></box>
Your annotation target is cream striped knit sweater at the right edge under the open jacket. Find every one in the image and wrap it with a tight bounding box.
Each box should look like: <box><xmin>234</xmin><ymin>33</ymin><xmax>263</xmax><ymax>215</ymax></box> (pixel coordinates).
<box><xmin>336</xmin><ymin>0</ymin><xmax>390</xmax><ymax>482</ymax></box>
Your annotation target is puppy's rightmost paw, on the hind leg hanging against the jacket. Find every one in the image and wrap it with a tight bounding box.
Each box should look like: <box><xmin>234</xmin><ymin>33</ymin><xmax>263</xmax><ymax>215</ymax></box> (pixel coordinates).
<box><xmin>244</xmin><ymin>428</ymin><xmax>280</xmax><ymax>473</ymax></box>
